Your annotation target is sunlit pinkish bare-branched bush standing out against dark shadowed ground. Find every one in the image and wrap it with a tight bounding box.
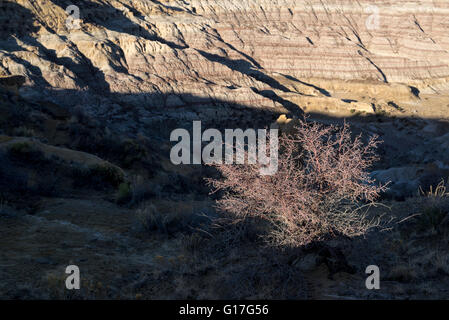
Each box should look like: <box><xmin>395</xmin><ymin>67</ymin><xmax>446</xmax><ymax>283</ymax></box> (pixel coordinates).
<box><xmin>208</xmin><ymin>120</ymin><xmax>386</xmax><ymax>246</ymax></box>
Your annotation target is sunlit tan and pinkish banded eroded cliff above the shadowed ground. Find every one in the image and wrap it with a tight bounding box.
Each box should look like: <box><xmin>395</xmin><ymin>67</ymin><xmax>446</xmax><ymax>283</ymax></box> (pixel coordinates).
<box><xmin>0</xmin><ymin>0</ymin><xmax>449</xmax><ymax>122</ymax></box>
